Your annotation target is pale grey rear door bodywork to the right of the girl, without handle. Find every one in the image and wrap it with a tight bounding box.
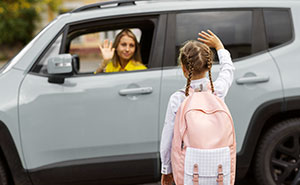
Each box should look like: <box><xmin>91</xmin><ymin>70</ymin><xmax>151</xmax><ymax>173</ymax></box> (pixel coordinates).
<box><xmin>225</xmin><ymin>53</ymin><xmax>283</xmax><ymax>152</ymax></box>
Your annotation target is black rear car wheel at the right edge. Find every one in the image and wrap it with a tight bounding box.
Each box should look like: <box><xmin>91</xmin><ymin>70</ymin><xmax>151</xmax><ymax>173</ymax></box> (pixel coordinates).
<box><xmin>254</xmin><ymin>119</ymin><xmax>300</xmax><ymax>185</ymax></box>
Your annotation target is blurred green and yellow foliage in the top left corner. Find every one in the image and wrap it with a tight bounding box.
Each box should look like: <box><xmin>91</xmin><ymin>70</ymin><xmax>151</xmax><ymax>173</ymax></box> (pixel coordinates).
<box><xmin>0</xmin><ymin>0</ymin><xmax>61</xmax><ymax>46</ymax></box>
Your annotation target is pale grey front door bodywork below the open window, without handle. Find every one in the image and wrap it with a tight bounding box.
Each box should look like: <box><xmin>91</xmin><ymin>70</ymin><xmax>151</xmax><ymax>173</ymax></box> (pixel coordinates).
<box><xmin>20</xmin><ymin>70</ymin><xmax>161</xmax><ymax>169</ymax></box>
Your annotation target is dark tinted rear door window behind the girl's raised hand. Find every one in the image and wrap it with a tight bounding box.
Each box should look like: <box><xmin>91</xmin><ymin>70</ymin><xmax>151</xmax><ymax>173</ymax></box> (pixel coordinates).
<box><xmin>176</xmin><ymin>10</ymin><xmax>253</xmax><ymax>64</ymax></box>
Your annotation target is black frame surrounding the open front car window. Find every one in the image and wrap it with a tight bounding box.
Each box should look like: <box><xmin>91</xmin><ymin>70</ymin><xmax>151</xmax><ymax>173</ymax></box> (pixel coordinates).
<box><xmin>29</xmin><ymin>12</ymin><xmax>167</xmax><ymax>78</ymax></box>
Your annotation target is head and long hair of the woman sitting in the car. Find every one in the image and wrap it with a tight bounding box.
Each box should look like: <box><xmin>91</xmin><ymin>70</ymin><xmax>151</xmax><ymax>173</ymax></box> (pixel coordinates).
<box><xmin>112</xmin><ymin>29</ymin><xmax>142</xmax><ymax>67</ymax></box>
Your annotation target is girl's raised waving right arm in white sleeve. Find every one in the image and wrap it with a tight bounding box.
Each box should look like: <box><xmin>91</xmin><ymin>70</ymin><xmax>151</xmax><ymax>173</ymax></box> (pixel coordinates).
<box><xmin>198</xmin><ymin>30</ymin><xmax>235</xmax><ymax>99</ymax></box>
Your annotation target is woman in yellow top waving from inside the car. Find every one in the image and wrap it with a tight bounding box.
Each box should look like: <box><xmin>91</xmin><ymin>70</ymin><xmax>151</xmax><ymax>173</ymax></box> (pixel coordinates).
<box><xmin>94</xmin><ymin>29</ymin><xmax>147</xmax><ymax>74</ymax></box>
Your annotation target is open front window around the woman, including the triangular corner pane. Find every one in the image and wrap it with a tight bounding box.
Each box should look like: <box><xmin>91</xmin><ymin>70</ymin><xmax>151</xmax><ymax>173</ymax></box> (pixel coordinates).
<box><xmin>31</xmin><ymin>16</ymin><xmax>158</xmax><ymax>76</ymax></box>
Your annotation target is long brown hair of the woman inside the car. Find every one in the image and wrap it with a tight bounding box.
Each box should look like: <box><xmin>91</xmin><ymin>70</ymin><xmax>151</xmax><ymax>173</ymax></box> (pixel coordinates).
<box><xmin>112</xmin><ymin>29</ymin><xmax>142</xmax><ymax>67</ymax></box>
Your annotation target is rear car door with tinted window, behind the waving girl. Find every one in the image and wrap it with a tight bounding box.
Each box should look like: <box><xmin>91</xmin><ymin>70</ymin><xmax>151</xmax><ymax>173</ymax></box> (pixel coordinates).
<box><xmin>160</xmin><ymin>9</ymin><xmax>283</xmax><ymax>158</ymax></box>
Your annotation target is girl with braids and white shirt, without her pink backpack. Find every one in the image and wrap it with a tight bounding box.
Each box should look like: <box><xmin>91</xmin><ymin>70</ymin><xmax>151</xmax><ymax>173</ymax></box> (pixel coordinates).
<box><xmin>160</xmin><ymin>30</ymin><xmax>234</xmax><ymax>185</ymax></box>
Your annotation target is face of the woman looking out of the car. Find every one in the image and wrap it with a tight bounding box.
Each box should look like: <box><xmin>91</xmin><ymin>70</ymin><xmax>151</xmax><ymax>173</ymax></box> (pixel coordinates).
<box><xmin>117</xmin><ymin>35</ymin><xmax>135</xmax><ymax>61</ymax></box>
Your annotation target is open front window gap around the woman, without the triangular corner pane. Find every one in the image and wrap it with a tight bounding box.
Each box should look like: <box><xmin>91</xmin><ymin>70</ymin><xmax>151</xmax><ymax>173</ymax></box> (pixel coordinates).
<box><xmin>63</xmin><ymin>17</ymin><xmax>157</xmax><ymax>75</ymax></box>
